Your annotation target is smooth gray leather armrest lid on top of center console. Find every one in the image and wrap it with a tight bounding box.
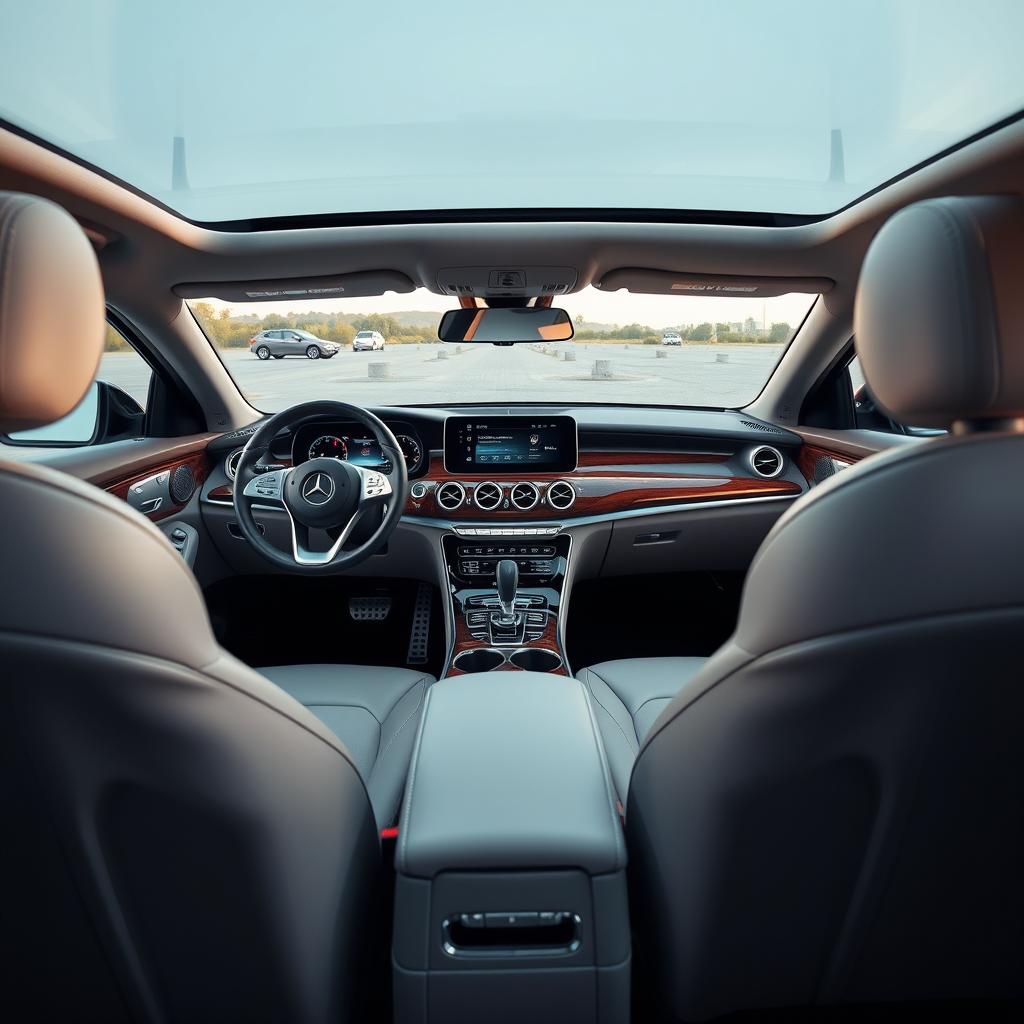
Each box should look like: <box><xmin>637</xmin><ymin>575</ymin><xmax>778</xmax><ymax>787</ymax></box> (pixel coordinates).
<box><xmin>395</xmin><ymin>672</ymin><xmax>626</xmax><ymax>879</ymax></box>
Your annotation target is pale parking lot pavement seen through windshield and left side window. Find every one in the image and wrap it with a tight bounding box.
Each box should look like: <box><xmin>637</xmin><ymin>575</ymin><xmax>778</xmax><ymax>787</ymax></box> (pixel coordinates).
<box><xmin>99</xmin><ymin>342</ymin><xmax>783</xmax><ymax>412</ymax></box>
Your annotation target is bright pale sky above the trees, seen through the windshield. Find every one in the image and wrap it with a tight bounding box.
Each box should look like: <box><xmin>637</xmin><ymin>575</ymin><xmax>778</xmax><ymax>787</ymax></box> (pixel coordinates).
<box><xmin>209</xmin><ymin>288</ymin><xmax>814</xmax><ymax>328</ymax></box>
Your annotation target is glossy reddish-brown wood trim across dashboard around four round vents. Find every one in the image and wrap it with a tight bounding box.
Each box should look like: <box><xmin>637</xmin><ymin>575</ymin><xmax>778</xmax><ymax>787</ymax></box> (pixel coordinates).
<box><xmin>406</xmin><ymin>452</ymin><xmax>802</xmax><ymax>523</ymax></box>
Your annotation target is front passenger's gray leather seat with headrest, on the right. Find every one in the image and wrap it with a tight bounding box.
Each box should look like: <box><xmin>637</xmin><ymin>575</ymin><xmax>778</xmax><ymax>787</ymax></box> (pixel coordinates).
<box><xmin>627</xmin><ymin>197</ymin><xmax>1024</xmax><ymax>1021</ymax></box>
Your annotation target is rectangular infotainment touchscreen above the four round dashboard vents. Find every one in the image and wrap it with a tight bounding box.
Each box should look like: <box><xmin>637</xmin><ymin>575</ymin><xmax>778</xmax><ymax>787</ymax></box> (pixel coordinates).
<box><xmin>444</xmin><ymin>416</ymin><xmax>577</xmax><ymax>473</ymax></box>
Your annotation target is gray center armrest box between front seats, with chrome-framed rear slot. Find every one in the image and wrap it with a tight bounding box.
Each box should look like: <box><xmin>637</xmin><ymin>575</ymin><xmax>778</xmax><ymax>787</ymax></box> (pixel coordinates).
<box><xmin>392</xmin><ymin>672</ymin><xmax>630</xmax><ymax>1024</ymax></box>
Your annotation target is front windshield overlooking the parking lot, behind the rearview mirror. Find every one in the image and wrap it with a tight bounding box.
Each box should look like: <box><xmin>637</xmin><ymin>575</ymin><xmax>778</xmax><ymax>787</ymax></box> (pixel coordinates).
<box><xmin>188</xmin><ymin>288</ymin><xmax>815</xmax><ymax>413</ymax></box>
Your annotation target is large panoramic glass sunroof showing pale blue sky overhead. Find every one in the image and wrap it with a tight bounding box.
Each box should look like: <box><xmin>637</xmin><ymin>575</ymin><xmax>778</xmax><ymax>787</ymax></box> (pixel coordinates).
<box><xmin>0</xmin><ymin>0</ymin><xmax>1024</xmax><ymax>221</ymax></box>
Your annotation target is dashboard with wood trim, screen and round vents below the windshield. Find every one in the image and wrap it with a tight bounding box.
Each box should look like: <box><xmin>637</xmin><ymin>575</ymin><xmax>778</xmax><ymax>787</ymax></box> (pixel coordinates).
<box><xmin>207</xmin><ymin>406</ymin><xmax>816</xmax><ymax>536</ymax></box>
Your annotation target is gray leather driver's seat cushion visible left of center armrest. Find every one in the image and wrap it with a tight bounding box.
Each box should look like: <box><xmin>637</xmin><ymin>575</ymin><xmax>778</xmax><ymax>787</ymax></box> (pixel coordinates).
<box><xmin>259</xmin><ymin>665</ymin><xmax>434</xmax><ymax>828</ymax></box>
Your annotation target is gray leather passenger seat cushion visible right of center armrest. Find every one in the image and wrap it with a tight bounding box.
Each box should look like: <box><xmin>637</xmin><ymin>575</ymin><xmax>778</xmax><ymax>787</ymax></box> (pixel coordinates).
<box><xmin>577</xmin><ymin>657</ymin><xmax>708</xmax><ymax>807</ymax></box>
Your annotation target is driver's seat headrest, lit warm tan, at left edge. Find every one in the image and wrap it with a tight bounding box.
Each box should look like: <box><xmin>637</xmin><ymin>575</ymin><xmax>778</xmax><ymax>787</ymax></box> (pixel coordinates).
<box><xmin>0</xmin><ymin>191</ymin><xmax>106</xmax><ymax>433</ymax></box>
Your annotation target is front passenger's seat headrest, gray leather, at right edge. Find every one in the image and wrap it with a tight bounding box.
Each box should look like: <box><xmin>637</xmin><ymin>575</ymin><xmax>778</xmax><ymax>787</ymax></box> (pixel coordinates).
<box><xmin>854</xmin><ymin>196</ymin><xmax>1024</xmax><ymax>429</ymax></box>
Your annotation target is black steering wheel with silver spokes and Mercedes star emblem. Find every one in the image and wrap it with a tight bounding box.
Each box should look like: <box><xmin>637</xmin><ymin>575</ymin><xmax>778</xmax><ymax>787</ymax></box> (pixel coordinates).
<box><xmin>232</xmin><ymin>401</ymin><xmax>409</xmax><ymax>573</ymax></box>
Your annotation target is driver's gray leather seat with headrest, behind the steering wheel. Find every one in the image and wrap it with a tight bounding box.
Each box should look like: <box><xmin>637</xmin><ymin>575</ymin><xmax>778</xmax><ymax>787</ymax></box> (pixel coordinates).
<box><xmin>0</xmin><ymin>194</ymin><xmax>403</xmax><ymax>1022</ymax></box>
